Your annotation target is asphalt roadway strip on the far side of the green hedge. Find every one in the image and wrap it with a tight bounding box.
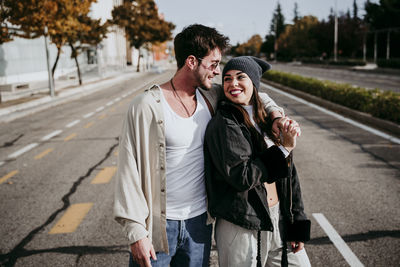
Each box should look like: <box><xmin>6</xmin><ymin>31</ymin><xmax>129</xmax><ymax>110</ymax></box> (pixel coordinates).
<box><xmin>272</xmin><ymin>63</ymin><xmax>400</xmax><ymax>92</ymax></box>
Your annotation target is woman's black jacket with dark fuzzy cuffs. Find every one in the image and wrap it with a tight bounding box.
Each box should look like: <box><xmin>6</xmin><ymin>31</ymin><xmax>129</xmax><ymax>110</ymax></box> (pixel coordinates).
<box><xmin>204</xmin><ymin>102</ymin><xmax>310</xmax><ymax>242</ymax></box>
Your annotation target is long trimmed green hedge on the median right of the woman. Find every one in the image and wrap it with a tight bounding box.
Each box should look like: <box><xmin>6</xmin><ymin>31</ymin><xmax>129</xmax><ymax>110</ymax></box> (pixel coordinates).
<box><xmin>263</xmin><ymin>70</ymin><xmax>400</xmax><ymax>124</ymax></box>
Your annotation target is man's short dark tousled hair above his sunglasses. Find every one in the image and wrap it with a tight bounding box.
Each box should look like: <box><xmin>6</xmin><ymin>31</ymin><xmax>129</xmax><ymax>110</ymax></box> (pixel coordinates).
<box><xmin>174</xmin><ymin>24</ymin><xmax>229</xmax><ymax>69</ymax></box>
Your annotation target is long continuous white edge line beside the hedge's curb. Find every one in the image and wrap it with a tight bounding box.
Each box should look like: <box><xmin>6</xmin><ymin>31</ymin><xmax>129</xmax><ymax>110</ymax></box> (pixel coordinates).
<box><xmin>264</xmin><ymin>84</ymin><xmax>400</xmax><ymax>144</ymax></box>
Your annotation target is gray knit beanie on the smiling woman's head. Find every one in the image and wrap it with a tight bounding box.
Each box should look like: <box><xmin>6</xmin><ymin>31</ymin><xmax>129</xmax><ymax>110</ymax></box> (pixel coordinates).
<box><xmin>222</xmin><ymin>56</ymin><xmax>271</xmax><ymax>90</ymax></box>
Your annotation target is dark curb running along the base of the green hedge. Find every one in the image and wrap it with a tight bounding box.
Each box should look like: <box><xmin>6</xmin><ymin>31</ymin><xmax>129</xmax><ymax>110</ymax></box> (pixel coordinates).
<box><xmin>261</xmin><ymin>79</ymin><xmax>400</xmax><ymax>137</ymax></box>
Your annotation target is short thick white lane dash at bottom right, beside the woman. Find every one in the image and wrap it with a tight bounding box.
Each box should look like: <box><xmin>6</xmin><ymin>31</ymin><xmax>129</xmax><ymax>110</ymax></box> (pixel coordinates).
<box><xmin>313</xmin><ymin>213</ymin><xmax>364</xmax><ymax>266</ymax></box>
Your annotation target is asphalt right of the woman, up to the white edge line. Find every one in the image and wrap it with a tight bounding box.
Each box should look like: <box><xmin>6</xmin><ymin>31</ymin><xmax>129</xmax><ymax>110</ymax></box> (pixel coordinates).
<box><xmin>260</xmin><ymin>82</ymin><xmax>400</xmax><ymax>266</ymax></box>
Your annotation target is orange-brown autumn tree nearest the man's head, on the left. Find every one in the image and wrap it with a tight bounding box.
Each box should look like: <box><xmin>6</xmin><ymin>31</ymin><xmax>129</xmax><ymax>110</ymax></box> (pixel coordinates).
<box><xmin>111</xmin><ymin>0</ymin><xmax>175</xmax><ymax>72</ymax></box>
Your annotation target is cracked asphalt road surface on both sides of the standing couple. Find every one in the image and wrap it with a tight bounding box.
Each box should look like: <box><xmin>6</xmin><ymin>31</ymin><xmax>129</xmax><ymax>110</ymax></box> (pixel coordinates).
<box><xmin>0</xmin><ymin>68</ymin><xmax>400</xmax><ymax>266</ymax></box>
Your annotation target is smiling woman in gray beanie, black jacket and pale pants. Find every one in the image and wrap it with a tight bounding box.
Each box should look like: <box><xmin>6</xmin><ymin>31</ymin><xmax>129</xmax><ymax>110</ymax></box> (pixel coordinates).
<box><xmin>204</xmin><ymin>56</ymin><xmax>310</xmax><ymax>267</ymax></box>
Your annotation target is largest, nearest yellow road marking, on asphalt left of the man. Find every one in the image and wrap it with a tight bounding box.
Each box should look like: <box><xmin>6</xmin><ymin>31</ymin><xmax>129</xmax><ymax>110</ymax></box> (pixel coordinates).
<box><xmin>49</xmin><ymin>203</ymin><xmax>93</xmax><ymax>234</ymax></box>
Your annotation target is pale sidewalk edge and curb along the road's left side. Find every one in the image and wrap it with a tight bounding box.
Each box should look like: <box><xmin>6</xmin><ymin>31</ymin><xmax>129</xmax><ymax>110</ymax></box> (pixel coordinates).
<box><xmin>0</xmin><ymin>72</ymin><xmax>142</xmax><ymax>123</ymax></box>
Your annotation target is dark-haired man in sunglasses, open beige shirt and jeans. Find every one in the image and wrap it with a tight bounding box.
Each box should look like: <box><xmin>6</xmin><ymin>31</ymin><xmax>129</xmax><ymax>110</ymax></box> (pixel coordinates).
<box><xmin>114</xmin><ymin>24</ymin><xmax>292</xmax><ymax>266</ymax></box>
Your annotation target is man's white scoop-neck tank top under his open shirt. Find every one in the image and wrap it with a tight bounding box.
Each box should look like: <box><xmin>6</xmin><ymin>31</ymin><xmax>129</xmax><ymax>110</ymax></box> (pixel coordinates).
<box><xmin>160</xmin><ymin>89</ymin><xmax>211</xmax><ymax>220</ymax></box>
